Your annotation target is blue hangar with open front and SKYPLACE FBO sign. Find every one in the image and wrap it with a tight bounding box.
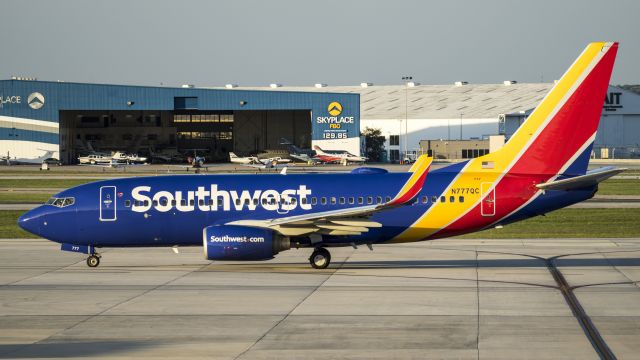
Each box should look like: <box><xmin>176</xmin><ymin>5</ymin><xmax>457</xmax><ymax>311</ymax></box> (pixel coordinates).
<box><xmin>0</xmin><ymin>79</ymin><xmax>360</xmax><ymax>164</ymax></box>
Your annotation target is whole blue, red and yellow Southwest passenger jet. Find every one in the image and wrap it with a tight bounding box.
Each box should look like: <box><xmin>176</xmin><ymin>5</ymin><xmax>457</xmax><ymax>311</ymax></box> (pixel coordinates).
<box><xmin>18</xmin><ymin>42</ymin><xmax>623</xmax><ymax>268</ymax></box>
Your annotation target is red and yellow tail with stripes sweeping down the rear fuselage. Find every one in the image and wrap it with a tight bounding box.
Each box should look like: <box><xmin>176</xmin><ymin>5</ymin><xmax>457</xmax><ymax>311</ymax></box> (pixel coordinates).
<box><xmin>393</xmin><ymin>42</ymin><xmax>618</xmax><ymax>242</ymax></box>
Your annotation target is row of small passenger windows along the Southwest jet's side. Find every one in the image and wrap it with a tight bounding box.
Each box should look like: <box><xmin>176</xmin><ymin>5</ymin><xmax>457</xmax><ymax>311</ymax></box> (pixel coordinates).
<box><xmin>124</xmin><ymin>195</ymin><xmax>464</xmax><ymax>207</ymax></box>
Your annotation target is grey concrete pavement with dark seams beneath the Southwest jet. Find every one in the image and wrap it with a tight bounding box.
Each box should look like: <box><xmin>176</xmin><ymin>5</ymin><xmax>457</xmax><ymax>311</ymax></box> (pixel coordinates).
<box><xmin>0</xmin><ymin>239</ymin><xmax>640</xmax><ymax>360</ymax></box>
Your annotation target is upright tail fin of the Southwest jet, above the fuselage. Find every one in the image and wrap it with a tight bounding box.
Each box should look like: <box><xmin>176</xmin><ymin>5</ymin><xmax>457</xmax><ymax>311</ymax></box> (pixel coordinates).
<box><xmin>488</xmin><ymin>42</ymin><xmax>618</xmax><ymax>176</ymax></box>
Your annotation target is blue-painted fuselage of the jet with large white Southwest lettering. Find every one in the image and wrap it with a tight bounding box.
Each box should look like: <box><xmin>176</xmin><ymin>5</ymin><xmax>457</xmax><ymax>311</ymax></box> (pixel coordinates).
<box><xmin>20</xmin><ymin>163</ymin><xmax>594</xmax><ymax>247</ymax></box>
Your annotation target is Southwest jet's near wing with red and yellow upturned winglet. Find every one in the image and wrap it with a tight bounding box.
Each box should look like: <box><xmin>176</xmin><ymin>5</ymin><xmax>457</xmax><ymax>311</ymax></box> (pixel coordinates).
<box><xmin>226</xmin><ymin>155</ymin><xmax>433</xmax><ymax>236</ymax></box>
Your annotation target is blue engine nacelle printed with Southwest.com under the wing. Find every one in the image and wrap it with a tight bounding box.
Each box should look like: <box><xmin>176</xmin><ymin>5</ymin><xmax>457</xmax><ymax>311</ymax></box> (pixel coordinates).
<box><xmin>202</xmin><ymin>225</ymin><xmax>291</xmax><ymax>260</ymax></box>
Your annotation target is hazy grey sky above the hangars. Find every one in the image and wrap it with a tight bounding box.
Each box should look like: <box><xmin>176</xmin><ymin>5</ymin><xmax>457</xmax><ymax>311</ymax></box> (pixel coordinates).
<box><xmin>0</xmin><ymin>0</ymin><xmax>640</xmax><ymax>86</ymax></box>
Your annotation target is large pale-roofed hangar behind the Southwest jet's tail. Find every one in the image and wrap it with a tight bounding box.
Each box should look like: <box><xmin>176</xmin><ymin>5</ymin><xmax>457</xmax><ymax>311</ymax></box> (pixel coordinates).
<box><xmin>251</xmin><ymin>80</ymin><xmax>640</xmax><ymax>162</ymax></box>
